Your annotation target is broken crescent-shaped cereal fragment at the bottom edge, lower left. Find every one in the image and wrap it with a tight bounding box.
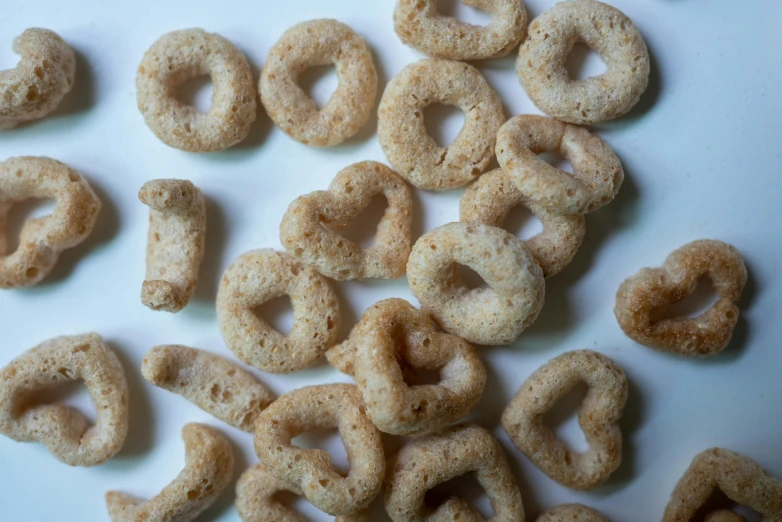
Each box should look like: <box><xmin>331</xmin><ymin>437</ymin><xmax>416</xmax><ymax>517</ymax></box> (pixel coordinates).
<box><xmin>106</xmin><ymin>422</ymin><xmax>234</xmax><ymax>522</ymax></box>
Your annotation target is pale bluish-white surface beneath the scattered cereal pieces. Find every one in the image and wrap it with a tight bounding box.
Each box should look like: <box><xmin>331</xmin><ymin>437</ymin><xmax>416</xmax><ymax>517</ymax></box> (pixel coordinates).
<box><xmin>0</xmin><ymin>0</ymin><xmax>782</xmax><ymax>521</ymax></box>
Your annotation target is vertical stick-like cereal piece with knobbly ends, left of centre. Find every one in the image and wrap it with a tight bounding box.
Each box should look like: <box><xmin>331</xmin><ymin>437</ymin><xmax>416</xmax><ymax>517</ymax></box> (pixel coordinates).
<box><xmin>138</xmin><ymin>179</ymin><xmax>206</xmax><ymax>312</ymax></box>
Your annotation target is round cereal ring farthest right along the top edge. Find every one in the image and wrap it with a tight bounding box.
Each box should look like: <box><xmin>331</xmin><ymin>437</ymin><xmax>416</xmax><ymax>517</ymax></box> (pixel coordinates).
<box><xmin>516</xmin><ymin>0</ymin><xmax>649</xmax><ymax>125</ymax></box>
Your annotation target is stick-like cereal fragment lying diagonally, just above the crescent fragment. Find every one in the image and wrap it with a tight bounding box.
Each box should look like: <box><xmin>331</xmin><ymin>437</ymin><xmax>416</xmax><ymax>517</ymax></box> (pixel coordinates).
<box><xmin>141</xmin><ymin>344</ymin><xmax>274</xmax><ymax>433</ymax></box>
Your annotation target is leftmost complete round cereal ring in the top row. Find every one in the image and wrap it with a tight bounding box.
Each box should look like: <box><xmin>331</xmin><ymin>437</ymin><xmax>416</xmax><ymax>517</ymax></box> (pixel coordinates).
<box><xmin>136</xmin><ymin>29</ymin><xmax>258</xmax><ymax>152</ymax></box>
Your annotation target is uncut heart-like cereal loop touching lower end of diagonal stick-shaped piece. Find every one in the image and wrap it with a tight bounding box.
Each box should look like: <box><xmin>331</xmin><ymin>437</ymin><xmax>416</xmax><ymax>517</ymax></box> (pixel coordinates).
<box><xmin>255</xmin><ymin>384</ymin><xmax>385</xmax><ymax>516</ymax></box>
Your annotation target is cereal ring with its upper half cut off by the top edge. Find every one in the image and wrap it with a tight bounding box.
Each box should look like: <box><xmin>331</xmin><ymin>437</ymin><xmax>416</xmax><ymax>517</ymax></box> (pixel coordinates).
<box><xmin>394</xmin><ymin>0</ymin><xmax>527</xmax><ymax>60</ymax></box>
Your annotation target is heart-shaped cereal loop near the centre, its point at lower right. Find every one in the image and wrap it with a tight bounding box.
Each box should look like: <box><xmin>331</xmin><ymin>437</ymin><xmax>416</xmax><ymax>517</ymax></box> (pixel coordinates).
<box><xmin>280</xmin><ymin>161</ymin><xmax>413</xmax><ymax>280</ymax></box>
